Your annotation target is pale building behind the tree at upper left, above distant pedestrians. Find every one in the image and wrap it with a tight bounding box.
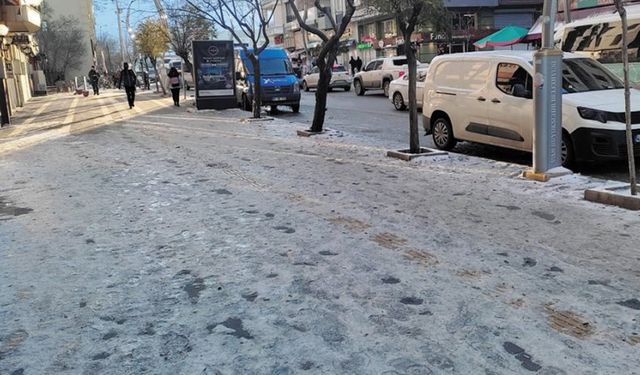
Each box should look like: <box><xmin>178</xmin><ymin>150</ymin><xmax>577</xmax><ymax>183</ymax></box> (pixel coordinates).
<box><xmin>46</xmin><ymin>0</ymin><xmax>97</xmax><ymax>80</ymax></box>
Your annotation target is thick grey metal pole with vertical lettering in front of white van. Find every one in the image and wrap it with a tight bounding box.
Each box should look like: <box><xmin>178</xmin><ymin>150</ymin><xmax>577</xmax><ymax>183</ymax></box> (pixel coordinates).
<box><xmin>533</xmin><ymin>0</ymin><xmax>564</xmax><ymax>176</ymax></box>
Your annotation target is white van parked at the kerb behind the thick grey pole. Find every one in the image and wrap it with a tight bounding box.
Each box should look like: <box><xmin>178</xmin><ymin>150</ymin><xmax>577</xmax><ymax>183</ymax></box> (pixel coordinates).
<box><xmin>422</xmin><ymin>51</ymin><xmax>640</xmax><ymax>166</ymax></box>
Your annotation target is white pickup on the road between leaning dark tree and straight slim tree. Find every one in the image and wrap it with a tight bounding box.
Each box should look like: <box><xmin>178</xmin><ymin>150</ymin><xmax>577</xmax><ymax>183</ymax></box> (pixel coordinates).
<box><xmin>353</xmin><ymin>56</ymin><xmax>407</xmax><ymax>97</ymax></box>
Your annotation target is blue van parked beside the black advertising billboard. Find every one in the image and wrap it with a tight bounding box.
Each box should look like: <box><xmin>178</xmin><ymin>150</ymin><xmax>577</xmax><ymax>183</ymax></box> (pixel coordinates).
<box><xmin>235</xmin><ymin>48</ymin><xmax>300</xmax><ymax>113</ymax></box>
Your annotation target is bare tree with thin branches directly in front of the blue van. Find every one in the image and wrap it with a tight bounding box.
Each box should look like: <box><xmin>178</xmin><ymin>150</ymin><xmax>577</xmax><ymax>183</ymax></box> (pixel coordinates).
<box><xmin>183</xmin><ymin>0</ymin><xmax>279</xmax><ymax>118</ymax></box>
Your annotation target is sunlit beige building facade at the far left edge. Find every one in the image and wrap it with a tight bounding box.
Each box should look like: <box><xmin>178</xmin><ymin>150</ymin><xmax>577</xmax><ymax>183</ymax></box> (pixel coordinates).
<box><xmin>0</xmin><ymin>0</ymin><xmax>47</xmax><ymax>124</ymax></box>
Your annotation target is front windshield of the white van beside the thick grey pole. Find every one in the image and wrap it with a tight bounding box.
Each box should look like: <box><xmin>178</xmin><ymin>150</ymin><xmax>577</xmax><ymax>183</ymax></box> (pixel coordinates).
<box><xmin>562</xmin><ymin>58</ymin><xmax>624</xmax><ymax>94</ymax></box>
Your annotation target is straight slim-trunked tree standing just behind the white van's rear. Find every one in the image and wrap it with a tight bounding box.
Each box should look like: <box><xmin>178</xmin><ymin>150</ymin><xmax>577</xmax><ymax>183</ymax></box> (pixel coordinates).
<box><xmin>366</xmin><ymin>0</ymin><xmax>449</xmax><ymax>154</ymax></box>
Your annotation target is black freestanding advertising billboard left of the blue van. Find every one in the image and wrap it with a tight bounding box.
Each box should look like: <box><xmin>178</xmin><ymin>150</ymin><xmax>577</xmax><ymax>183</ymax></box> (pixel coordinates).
<box><xmin>193</xmin><ymin>40</ymin><xmax>237</xmax><ymax>109</ymax></box>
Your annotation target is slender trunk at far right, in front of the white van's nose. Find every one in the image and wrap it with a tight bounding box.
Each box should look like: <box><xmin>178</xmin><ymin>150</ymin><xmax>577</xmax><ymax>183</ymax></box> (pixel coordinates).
<box><xmin>615</xmin><ymin>0</ymin><xmax>638</xmax><ymax>195</ymax></box>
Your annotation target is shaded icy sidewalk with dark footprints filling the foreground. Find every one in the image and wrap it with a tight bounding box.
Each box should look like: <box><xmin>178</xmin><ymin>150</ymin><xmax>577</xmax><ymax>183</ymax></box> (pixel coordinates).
<box><xmin>0</xmin><ymin>101</ymin><xmax>640</xmax><ymax>375</ymax></box>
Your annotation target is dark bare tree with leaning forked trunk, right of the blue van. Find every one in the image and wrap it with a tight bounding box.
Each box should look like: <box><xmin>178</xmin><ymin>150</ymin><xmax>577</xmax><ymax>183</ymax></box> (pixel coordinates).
<box><xmin>289</xmin><ymin>0</ymin><xmax>356</xmax><ymax>133</ymax></box>
